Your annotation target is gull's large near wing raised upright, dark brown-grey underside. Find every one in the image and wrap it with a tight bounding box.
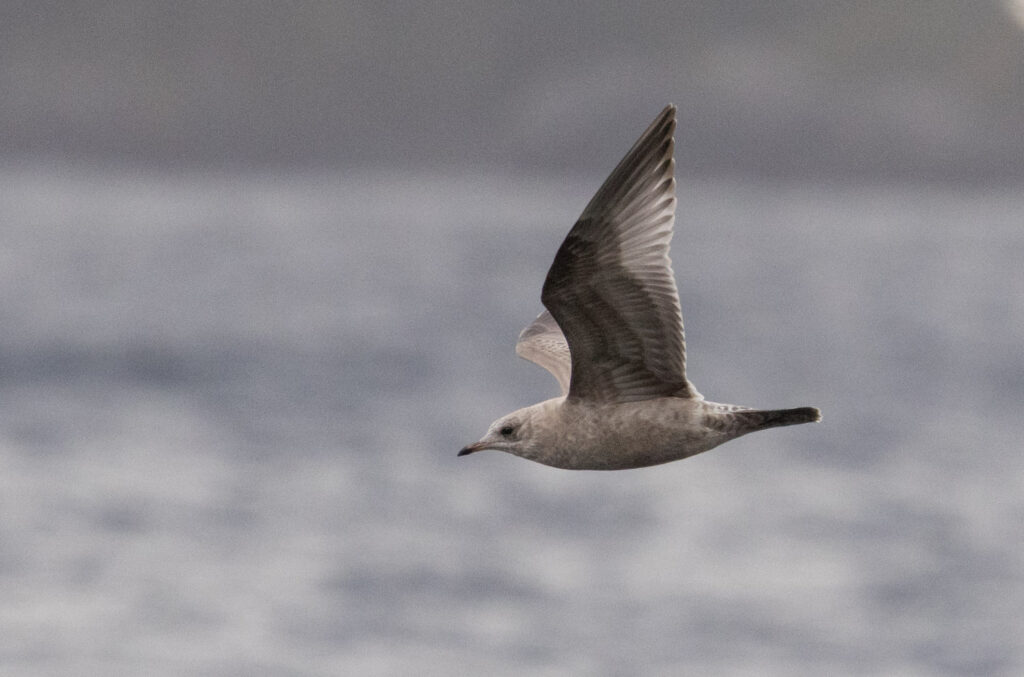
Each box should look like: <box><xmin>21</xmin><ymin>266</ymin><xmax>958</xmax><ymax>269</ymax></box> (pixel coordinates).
<box><xmin>541</xmin><ymin>105</ymin><xmax>700</xmax><ymax>401</ymax></box>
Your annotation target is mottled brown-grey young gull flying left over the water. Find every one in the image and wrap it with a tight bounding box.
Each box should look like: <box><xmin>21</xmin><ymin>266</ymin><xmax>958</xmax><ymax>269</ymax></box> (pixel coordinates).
<box><xmin>459</xmin><ymin>104</ymin><xmax>821</xmax><ymax>470</ymax></box>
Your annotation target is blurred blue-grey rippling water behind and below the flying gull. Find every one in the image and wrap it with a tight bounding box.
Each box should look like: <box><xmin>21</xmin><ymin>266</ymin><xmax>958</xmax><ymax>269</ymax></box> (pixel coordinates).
<box><xmin>0</xmin><ymin>167</ymin><xmax>1024</xmax><ymax>676</ymax></box>
